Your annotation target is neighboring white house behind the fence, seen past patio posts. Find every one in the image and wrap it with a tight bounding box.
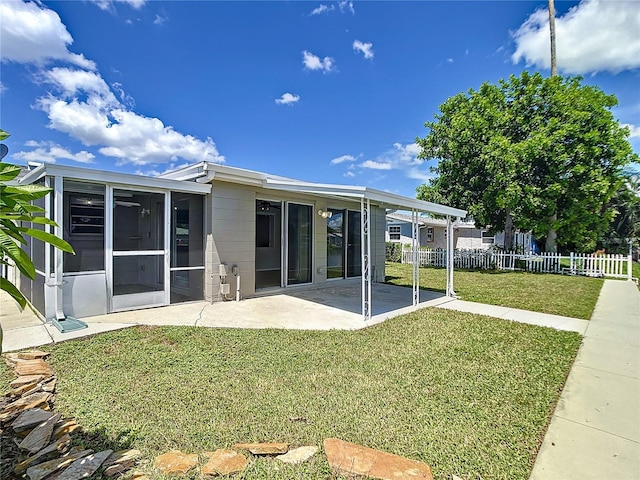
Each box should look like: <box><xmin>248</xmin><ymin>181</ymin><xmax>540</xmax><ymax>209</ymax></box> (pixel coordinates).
<box><xmin>386</xmin><ymin>212</ymin><xmax>531</xmax><ymax>250</ymax></box>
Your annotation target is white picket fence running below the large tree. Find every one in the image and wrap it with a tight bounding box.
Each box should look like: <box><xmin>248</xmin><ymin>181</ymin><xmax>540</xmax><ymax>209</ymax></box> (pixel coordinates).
<box><xmin>402</xmin><ymin>249</ymin><xmax>632</xmax><ymax>280</ymax></box>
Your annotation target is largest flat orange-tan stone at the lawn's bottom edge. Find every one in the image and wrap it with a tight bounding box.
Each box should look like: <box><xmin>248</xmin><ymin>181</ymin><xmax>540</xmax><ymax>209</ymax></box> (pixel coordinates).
<box><xmin>324</xmin><ymin>438</ymin><xmax>433</xmax><ymax>480</ymax></box>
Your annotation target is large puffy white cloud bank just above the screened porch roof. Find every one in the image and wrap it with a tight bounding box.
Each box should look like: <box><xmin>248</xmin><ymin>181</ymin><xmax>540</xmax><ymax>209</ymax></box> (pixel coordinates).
<box><xmin>38</xmin><ymin>68</ymin><xmax>224</xmax><ymax>165</ymax></box>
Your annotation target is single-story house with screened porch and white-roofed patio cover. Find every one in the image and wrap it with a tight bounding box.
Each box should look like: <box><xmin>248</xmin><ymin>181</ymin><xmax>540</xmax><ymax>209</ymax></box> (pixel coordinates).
<box><xmin>12</xmin><ymin>162</ymin><xmax>466</xmax><ymax>319</ymax></box>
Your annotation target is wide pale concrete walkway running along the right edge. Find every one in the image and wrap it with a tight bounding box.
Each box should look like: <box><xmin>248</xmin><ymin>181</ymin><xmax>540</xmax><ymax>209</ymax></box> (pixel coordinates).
<box><xmin>531</xmin><ymin>280</ymin><xmax>640</xmax><ymax>480</ymax></box>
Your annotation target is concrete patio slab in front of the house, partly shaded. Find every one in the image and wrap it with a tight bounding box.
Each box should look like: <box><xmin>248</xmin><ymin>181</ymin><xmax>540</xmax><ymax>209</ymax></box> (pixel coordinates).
<box><xmin>0</xmin><ymin>282</ymin><xmax>452</xmax><ymax>352</ymax></box>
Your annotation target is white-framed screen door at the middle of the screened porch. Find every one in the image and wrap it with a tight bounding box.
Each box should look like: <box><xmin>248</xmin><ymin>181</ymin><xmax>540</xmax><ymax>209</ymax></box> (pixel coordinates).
<box><xmin>110</xmin><ymin>189</ymin><xmax>169</xmax><ymax>311</ymax></box>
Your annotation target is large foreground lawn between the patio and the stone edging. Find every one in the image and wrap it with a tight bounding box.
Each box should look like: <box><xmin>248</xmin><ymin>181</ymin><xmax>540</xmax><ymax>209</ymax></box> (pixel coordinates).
<box><xmin>3</xmin><ymin>309</ymin><xmax>580</xmax><ymax>480</ymax></box>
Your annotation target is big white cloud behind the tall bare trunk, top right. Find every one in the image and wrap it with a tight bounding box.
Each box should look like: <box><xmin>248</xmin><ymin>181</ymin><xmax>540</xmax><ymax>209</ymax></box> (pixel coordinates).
<box><xmin>511</xmin><ymin>0</ymin><xmax>640</xmax><ymax>74</ymax></box>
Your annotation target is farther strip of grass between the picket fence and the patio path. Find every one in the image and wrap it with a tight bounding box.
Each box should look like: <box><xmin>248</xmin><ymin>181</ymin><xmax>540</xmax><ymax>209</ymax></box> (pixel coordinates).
<box><xmin>386</xmin><ymin>263</ymin><xmax>603</xmax><ymax>320</ymax></box>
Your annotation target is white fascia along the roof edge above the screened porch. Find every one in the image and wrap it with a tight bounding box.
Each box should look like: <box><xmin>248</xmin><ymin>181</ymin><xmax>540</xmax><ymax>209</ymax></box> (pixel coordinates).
<box><xmin>20</xmin><ymin>164</ymin><xmax>211</xmax><ymax>194</ymax></box>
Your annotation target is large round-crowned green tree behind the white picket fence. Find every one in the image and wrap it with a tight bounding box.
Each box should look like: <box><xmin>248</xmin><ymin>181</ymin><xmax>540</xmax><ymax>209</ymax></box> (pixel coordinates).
<box><xmin>416</xmin><ymin>72</ymin><xmax>638</xmax><ymax>251</ymax></box>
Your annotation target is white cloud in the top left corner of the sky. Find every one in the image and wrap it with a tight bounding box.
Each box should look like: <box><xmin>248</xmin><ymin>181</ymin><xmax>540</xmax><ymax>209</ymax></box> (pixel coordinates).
<box><xmin>0</xmin><ymin>1</ymin><xmax>96</xmax><ymax>70</ymax></box>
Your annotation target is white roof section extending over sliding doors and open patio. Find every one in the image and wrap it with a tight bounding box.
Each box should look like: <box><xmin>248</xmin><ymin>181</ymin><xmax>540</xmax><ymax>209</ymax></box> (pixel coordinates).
<box><xmin>160</xmin><ymin>162</ymin><xmax>467</xmax><ymax>218</ymax></box>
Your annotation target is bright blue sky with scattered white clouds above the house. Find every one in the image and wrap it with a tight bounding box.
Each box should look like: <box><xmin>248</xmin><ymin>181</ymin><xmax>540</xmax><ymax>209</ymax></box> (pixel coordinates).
<box><xmin>0</xmin><ymin>0</ymin><xmax>640</xmax><ymax>197</ymax></box>
